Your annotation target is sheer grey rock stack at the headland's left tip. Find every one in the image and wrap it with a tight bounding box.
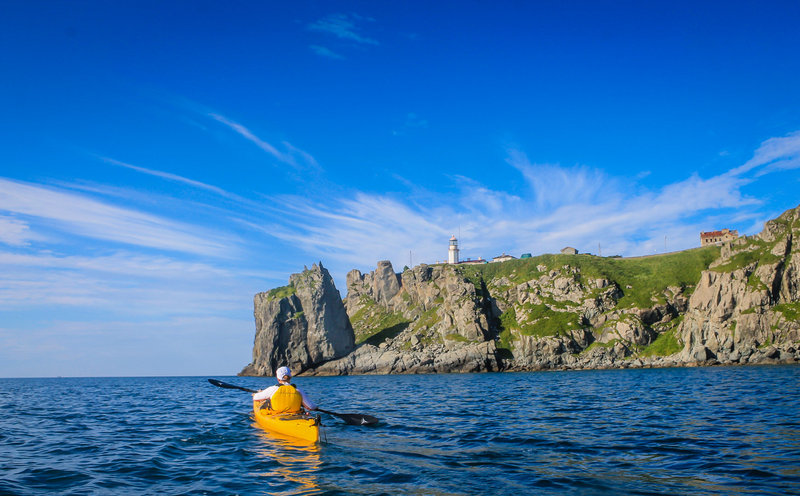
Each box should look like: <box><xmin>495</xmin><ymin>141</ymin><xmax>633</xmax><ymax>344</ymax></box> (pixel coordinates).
<box><xmin>240</xmin><ymin>263</ymin><xmax>354</xmax><ymax>376</ymax></box>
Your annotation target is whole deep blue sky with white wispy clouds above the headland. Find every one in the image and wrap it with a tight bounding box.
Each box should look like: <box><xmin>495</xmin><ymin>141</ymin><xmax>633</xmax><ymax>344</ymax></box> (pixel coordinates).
<box><xmin>0</xmin><ymin>1</ymin><xmax>800</xmax><ymax>377</ymax></box>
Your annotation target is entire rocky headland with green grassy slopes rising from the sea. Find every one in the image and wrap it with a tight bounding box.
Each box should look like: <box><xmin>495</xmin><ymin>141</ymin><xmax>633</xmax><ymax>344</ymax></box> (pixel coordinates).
<box><xmin>241</xmin><ymin>202</ymin><xmax>800</xmax><ymax>375</ymax></box>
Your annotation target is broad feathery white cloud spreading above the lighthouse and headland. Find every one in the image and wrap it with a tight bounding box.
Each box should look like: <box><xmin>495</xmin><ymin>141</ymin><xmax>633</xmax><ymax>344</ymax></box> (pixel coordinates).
<box><xmin>255</xmin><ymin>133</ymin><xmax>800</xmax><ymax>278</ymax></box>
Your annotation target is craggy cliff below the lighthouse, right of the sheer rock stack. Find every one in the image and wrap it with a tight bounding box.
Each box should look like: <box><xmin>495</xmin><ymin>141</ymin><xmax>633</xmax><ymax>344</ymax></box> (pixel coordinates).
<box><xmin>314</xmin><ymin>261</ymin><xmax>499</xmax><ymax>374</ymax></box>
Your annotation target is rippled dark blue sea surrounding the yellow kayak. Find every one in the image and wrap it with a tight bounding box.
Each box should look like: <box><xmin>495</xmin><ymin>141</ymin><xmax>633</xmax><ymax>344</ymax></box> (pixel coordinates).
<box><xmin>0</xmin><ymin>366</ymin><xmax>800</xmax><ymax>495</ymax></box>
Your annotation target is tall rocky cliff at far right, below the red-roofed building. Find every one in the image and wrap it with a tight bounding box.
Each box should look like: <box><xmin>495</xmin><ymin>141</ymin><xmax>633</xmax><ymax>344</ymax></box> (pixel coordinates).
<box><xmin>678</xmin><ymin>207</ymin><xmax>800</xmax><ymax>363</ymax></box>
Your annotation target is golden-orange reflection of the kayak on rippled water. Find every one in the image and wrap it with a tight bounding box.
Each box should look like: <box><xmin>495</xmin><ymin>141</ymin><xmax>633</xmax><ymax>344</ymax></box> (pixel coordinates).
<box><xmin>252</xmin><ymin>422</ymin><xmax>322</xmax><ymax>495</ymax></box>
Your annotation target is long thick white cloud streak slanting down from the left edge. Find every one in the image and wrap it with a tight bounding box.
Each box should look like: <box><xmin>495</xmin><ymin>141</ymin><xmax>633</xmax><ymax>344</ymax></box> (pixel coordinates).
<box><xmin>0</xmin><ymin>178</ymin><xmax>230</xmax><ymax>256</ymax></box>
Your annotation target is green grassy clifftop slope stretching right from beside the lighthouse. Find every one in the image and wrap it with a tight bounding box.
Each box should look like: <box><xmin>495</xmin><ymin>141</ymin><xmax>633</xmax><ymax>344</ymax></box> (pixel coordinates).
<box><xmin>457</xmin><ymin>246</ymin><xmax>720</xmax><ymax>308</ymax></box>
